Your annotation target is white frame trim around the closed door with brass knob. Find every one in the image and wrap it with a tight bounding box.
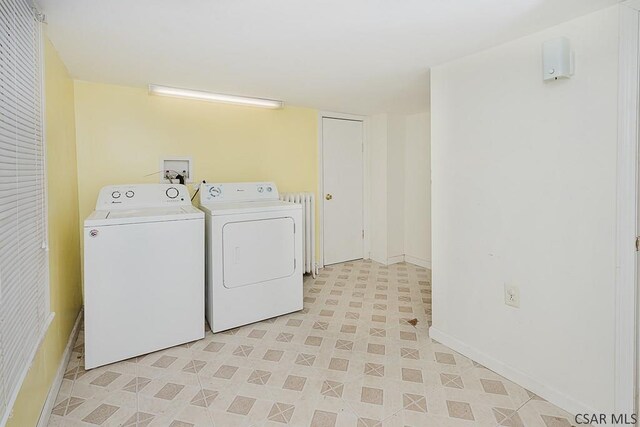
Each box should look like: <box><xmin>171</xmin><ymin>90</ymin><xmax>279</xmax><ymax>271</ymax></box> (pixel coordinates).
<box><xmin>317</xmin><ymin>111</ymin><xmax>371</xmax><ymax>268</ymax></box>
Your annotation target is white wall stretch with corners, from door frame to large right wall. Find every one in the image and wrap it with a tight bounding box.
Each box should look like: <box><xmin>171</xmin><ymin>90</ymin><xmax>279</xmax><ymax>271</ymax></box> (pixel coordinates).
<box><xmin>369</xmin><ymin>113</ymin><xmax>431</xmax><ymax>267</ymax></box>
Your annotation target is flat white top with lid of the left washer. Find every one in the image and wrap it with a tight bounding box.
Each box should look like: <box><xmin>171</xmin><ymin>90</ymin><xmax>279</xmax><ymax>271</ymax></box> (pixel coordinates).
<box><xmin>84</xmin><ymin>206</ymin><xmax>204</xmax><ymax>227</ymax></box>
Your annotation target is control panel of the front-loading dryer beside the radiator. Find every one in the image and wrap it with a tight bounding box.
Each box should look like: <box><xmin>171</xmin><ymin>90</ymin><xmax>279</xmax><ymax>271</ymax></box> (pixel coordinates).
<box><xmin>200</xmin><ymin>182</ymin><xmax>278</xmax><ymax>205</ymax></box>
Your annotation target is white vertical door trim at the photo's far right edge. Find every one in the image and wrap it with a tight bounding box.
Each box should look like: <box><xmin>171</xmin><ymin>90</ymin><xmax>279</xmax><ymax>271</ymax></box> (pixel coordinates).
<box><xmin>614</xmin><ymin>0</ymin><xmax>640</xmax><ymax>413</ymax></box>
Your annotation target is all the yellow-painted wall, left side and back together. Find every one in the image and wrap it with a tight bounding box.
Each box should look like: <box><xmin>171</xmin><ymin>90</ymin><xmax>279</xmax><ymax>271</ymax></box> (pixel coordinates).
<box><xmin>8</xmin><ymin>74</ymin><xmax>318</xmax><ymax>427</ymax></box>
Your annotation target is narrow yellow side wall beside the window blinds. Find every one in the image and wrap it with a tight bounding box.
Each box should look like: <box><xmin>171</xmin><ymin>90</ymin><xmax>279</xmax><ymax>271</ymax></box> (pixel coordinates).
<box><xmin>8</xmin><ymin>40</ymin><xmax>82</xmax><ymax>427</ymax></box>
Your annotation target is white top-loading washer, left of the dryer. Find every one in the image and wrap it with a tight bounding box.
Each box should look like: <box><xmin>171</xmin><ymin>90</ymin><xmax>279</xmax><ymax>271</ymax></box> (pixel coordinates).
<box><xmin>84</xmin><ymin>184</ymin><xmax>204</xmax><ymax>369</ymax></box>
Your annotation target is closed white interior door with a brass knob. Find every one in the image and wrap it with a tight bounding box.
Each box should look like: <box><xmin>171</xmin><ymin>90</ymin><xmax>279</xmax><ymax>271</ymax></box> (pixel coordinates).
<box><xmin>322</xmin><ymin>117</ymin><xmax>364</xmax><ymax>264</ymax></box>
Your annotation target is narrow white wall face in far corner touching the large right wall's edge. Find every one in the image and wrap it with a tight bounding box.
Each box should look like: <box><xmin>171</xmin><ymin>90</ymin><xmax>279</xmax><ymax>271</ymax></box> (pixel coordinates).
<box><xmin>404</xmin><ymin>113</ymin><xmax>431</xmax><ymax>268</ymax></box>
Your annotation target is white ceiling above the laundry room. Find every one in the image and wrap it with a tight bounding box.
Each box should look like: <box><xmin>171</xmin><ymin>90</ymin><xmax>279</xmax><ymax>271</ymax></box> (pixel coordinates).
<box><xmin>39</xmin><ymin>0</ymin><xmax>617</xmax><ymax>114</ymax></box>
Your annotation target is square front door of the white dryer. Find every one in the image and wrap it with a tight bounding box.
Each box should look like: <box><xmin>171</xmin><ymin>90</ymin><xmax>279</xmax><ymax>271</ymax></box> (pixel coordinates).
<box><xmin>222</xmin><ymin>217</ymin><xmax>295</xmax><ymax>288</ymax></box>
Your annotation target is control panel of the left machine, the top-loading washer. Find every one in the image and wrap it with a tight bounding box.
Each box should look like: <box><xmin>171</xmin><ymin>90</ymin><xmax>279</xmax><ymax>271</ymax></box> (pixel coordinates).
<box><xmin>96</xmin><ymin>184</ymin><xmax>191</xmax><ymax>210</ymax></box>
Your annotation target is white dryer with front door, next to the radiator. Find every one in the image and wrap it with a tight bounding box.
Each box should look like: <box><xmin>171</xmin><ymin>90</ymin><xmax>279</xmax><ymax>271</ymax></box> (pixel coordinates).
<box><xmin>200</xmin><ymin>182</ymin><xmax>303</xmax><ymax>332</ymax></box>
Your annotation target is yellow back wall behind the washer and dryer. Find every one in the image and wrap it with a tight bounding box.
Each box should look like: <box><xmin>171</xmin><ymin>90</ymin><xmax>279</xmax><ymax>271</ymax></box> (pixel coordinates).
<box><xmin>75</xmin><ymin>81</ymin><xmax>318</xmax><ymax>251</ymax></box>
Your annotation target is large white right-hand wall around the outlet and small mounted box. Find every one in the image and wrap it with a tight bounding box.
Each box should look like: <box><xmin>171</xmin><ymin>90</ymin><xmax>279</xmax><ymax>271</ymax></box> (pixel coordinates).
<box><xmin>431</xmin><ymin>6</ymin><xmax>618</xmax><ymax>412</ymax></box>
